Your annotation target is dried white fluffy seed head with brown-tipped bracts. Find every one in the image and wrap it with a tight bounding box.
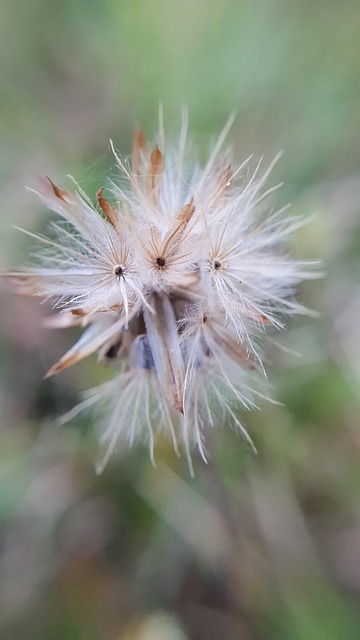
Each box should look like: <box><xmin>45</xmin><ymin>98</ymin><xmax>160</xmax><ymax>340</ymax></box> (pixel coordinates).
<box><xmin>4</xmin><ymin>117</ymin><xmax>311</xmax><ymax>469</ymax></box>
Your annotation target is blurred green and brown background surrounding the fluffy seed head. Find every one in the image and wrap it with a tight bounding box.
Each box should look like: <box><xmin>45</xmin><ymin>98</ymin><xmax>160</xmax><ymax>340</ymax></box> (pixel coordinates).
<box><xmin>0</xmin><ymin>0</ymin><xmax>360</xmax><ymax>640</ymax></box>
